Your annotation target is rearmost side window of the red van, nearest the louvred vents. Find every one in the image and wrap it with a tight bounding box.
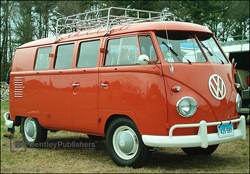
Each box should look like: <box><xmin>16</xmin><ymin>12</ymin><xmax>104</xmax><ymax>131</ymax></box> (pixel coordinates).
<box><xmin>35</xmin><ymin>47</ymin><xmax>52</xmax><ymax>70</ymax></box>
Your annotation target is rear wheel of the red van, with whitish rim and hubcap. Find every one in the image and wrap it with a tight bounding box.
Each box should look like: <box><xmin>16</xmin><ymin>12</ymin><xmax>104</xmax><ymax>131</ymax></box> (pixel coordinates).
<box><xmin>21</xmin><ymin>117</ymin><xmax>47</xmax><ymax>147</ymax></box>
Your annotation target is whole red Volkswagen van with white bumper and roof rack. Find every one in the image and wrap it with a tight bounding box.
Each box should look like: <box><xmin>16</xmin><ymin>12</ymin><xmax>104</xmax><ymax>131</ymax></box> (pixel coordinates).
<box><xmin>6</xmin><ymin>7</ymin><xmax>246</xmax><ymax>167</ymax></box>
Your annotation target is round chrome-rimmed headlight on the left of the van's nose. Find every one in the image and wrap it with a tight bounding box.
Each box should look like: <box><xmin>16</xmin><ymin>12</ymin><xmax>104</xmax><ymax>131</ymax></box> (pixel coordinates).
<box><xmin>176</xmin><ymin>97</ymin><xmax>198</xmax><ymax>117</ymax></box>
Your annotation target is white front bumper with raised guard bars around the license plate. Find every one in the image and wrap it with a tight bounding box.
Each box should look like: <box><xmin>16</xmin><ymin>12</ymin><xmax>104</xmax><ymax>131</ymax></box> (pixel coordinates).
<box><xmin>142</xmin><ymin>116</ymin><xmax>246</xmax><ymax>148</ymax></box>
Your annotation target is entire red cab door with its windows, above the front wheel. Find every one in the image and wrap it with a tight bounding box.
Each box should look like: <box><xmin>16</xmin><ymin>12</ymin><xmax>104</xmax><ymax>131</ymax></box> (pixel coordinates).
<box><xmin>99</xmin><ymin>35</ymin><xmax>167</xmax><ymax>134</ymax></box>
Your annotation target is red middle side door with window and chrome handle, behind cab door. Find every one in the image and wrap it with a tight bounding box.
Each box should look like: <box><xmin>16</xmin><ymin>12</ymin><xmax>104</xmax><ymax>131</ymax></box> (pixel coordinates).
<box><xmin>72</xmin><ymin>40</ymin><xmax>100</xmax><ymax>131</ymax></box>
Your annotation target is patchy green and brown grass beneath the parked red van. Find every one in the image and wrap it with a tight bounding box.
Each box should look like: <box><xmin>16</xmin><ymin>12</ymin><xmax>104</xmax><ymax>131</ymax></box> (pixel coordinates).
<box><xmin>1</xmin><ymin>103</ymin><xmax>249</xmax><ymax>173</ymax></box>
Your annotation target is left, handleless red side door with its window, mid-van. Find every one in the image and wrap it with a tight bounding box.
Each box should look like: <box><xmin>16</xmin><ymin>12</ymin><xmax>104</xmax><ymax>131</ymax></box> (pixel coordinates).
<box><xmin>47</xmin><ymin>43</ymin><xmax>75</xmax><ymax>130</ymax></box>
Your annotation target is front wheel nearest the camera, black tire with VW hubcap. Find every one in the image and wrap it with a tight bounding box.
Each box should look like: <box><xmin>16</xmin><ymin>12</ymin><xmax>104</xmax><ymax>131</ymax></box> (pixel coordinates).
<box><xmin>106</xmin><ymin>117</ymin><xmax>152</xmax><ymax>168</ymax></box>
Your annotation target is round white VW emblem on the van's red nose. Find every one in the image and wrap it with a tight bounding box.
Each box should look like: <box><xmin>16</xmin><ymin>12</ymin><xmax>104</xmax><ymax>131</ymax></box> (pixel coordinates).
<box><xmin>208</xmin><ymin>74</ymin><xmax>226</xmax><ymax>100</ymax></box>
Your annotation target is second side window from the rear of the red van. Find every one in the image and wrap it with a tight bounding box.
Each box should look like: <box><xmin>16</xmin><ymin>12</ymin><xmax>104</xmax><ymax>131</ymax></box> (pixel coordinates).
<box><xmin>54</xmin><ymin>44</ymin><xmax>74</xmax><ymax>69</ymax></box>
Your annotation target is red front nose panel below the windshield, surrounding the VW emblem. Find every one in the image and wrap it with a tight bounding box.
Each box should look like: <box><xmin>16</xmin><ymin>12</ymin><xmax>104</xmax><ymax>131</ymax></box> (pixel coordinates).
<box><xmin>163</xmin><ymin>63</ymin><xmax>238</xmax><ymax>135</ymax></box>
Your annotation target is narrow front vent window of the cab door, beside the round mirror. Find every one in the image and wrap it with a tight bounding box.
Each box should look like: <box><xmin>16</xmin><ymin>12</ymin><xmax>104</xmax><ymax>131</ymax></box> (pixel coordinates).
<box><xmin>139</xmin><ymin>36</ymin><xmax>157</xmax><ymax>60</ymax></box>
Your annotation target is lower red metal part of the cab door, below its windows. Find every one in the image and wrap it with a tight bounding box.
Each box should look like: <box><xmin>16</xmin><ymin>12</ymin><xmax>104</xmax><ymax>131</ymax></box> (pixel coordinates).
<box><xmin>99</xmin><ymin>65</ymin><xmax>167</xmax><ymax>134</ymax></box>
